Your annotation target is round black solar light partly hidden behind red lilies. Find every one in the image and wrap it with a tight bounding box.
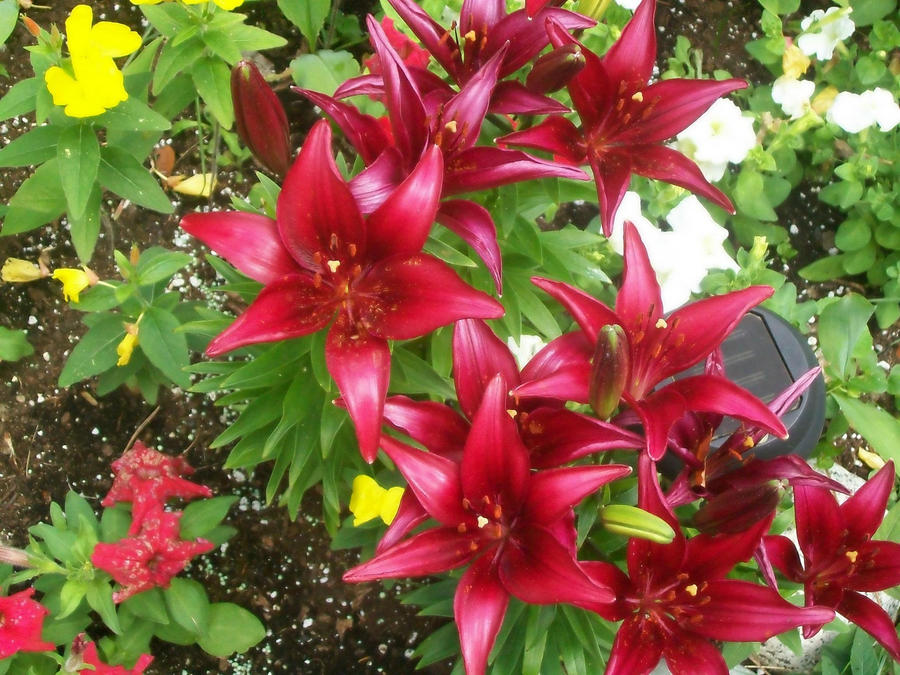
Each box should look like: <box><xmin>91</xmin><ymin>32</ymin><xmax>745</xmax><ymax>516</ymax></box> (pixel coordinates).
<box><xmin>677</xmin><ymin>307</ymin><xmax>825</xmax><ymax>459</ymax></box>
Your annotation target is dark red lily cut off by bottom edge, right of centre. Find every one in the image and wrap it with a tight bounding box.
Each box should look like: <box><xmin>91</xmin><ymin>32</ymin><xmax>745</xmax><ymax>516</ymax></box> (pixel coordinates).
<box><xmin>583</xmin><ymin>455</ymin><xmax>834</xmax><ymax>675</ymax></box>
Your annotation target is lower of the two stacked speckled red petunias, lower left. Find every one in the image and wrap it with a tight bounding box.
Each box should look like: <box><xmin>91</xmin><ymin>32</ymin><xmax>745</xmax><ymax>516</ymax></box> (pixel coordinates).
<box><xmin>91</xmin><ymin>510</ymin><xmax>213</xmax><ymax>603</ymax></box>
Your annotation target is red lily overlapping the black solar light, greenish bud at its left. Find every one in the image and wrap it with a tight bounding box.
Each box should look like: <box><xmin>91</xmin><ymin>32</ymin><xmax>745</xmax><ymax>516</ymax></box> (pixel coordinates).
<box><xmin>532</xmin><ymin>222</ymin><xmax>787</xmax><ymax>461</ymax></box>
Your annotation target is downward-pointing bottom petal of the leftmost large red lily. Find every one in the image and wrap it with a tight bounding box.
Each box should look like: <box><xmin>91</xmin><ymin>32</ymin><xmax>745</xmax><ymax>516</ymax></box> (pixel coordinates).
<box><xmin>325</xmin><ymin>312</ymin><xmax>391</xmax><ymax>464</ymax></box>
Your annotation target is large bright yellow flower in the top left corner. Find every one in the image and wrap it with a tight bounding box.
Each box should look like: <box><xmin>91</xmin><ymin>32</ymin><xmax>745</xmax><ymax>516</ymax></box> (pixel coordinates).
<box><xmin>44</xmin><ymin>5</ymin><xmax>141</xmax><ymax>117</ymax></box>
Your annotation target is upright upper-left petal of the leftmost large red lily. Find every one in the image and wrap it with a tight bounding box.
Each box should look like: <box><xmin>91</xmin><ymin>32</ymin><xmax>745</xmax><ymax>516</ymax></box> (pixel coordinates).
<box><xmin>276</xmin><ymin>120</ymin><xmax>365</xmax><ymax>271</ymax></box>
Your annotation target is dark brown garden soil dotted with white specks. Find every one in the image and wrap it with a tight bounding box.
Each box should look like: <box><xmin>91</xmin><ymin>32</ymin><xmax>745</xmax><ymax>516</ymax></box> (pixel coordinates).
<box><xmin>0</xmin><ymin>0</ymin><xmax>896</xmax><ymax>675</ymax></box>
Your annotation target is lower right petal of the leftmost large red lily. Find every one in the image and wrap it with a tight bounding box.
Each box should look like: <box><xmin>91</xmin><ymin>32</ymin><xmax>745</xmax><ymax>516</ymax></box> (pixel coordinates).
<box><xmin>356</xmin><ymin>253</ymin><xmax>503</xmax><ymax>340</ymax></box>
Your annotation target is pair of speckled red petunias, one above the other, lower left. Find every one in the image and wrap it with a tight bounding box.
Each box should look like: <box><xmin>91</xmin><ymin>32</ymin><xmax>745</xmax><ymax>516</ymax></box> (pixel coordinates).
<box><xmin>91</xmin><ymin>441</ymin><xmax>213</xmax><ymax>603</ymax></box>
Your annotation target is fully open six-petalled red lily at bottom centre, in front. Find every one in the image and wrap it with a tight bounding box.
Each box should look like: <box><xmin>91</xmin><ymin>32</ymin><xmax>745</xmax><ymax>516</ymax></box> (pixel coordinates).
<box><xmin>344</xmin><ymin>375</ymin><xmax>630</xmax><ymax>675</ymax></box>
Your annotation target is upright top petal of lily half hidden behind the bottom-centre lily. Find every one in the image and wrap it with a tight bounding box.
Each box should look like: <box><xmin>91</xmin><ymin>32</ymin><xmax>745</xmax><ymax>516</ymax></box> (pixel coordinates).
<box><xmin>453</xmin><ymin>319</ymin><xmax>519</xmax><ymax>419</ymax></box>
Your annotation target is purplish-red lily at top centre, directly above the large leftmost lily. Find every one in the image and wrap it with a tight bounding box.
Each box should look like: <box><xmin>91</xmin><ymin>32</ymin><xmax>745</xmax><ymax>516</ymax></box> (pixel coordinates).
<box><xmin>297</xmin><ymin>17</ymin><xmax>586</xmax><ymax>292</ymax></box>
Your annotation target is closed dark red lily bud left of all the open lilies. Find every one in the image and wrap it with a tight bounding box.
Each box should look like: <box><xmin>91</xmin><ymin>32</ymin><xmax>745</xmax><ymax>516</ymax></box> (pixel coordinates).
<box><xmin>231</xmin><ymin>61</ymin><xmax>291</xmax><ymax>176</ymax></box>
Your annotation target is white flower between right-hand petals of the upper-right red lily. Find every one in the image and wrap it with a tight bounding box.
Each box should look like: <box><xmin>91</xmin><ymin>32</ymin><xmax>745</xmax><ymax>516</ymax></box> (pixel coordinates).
<box><xmin>675</xmin><ymin>98</ymin><xmax>756</xmax><ymax>181</ymax></box>
